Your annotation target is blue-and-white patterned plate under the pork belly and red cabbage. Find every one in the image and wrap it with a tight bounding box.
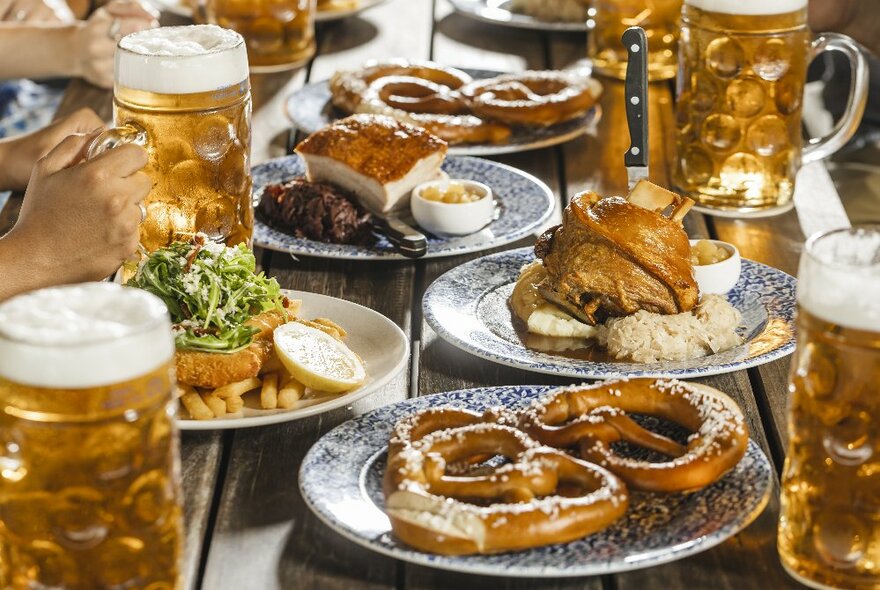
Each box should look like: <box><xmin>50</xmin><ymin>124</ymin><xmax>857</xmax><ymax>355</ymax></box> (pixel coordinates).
<box><xmin>253</xmin><ymin>155</ymin><xmax>555</xmax><ymax>260</ymax></box>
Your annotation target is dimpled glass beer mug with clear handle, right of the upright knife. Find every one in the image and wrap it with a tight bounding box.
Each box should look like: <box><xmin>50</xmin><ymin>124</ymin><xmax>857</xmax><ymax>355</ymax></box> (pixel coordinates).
<box><xmin>672</xmin><ymin>0</ymin><xmax>868</xmax><ymax>216</ymax></box>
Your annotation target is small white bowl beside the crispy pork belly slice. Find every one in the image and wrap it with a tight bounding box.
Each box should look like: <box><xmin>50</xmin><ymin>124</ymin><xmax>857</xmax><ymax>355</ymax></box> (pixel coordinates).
<box><xmin>410</xmin><ymin>179</ymin><xmax>495</xmax><ymax>236</ymax></box>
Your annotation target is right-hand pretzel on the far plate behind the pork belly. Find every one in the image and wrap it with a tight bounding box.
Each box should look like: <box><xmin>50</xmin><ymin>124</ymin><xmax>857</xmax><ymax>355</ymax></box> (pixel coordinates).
<box><xmin>461</xmin><ymin>71</ymin><xmax>602</xmax><ymax>126</ymax></box>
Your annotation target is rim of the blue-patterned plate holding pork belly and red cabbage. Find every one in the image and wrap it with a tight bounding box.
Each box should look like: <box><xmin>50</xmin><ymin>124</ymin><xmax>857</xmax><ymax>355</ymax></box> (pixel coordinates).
<box><xmin>251</xmin><ymin>154</ymin><xmax>556</xmax><ymax>262</ymax></box>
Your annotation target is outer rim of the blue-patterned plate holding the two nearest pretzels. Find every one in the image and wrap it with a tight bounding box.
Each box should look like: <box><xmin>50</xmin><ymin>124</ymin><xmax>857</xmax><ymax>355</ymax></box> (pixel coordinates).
<box><xmin>297</xmin><ymin>383</ymin><xmax>778</xmax><ymax>578</ymax></box>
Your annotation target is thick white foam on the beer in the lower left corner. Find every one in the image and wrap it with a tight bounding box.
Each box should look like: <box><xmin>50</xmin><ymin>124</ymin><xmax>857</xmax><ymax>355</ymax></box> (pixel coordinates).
<box><xmin>0</xmin><ymin>283</ymin><xmax>174</xmax><ymax>389</ymax></box>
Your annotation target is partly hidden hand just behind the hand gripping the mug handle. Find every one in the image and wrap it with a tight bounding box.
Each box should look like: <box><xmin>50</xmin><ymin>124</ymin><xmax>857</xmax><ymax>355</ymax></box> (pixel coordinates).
<box><xmin>0</xmin><ymin>108</ymin><xmax>104</xmax><ymax>190</ymax></box>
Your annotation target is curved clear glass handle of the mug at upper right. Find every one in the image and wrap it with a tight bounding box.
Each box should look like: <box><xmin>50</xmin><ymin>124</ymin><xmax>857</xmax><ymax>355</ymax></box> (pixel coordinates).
<box><xmin>802</xmin><ymin>33</ymin><xmax>868</xmax><ymax>164</ymax></box>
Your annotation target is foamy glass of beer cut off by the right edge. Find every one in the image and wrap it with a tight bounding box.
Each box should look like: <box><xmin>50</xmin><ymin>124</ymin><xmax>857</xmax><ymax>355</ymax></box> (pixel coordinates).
<box><xmin>778</xmin><ymin>228</ymin><xmax>880</xmax><ymax>590</ymax></box>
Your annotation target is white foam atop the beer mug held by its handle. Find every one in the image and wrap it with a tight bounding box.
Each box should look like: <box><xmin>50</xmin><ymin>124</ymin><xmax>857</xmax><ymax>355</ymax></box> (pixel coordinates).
<box><xmin>116</xmin><ymin>25</ymin><xmax>248</xmax><ymax>94</ymax></box>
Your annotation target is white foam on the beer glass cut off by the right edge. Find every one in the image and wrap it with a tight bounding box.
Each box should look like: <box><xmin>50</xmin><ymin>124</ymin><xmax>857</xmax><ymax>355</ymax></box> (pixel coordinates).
<box><xmin>798</xmin><ymin>230</ymin><xmax>880</xmax><ymax>333</ymax></box>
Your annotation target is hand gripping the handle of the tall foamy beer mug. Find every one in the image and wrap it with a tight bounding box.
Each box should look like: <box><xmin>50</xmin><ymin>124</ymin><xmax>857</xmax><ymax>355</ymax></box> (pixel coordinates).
<box><xmin>2</xmin><ymin>133</ymin><xmax>152</xmax><ymax>288</ymax></box>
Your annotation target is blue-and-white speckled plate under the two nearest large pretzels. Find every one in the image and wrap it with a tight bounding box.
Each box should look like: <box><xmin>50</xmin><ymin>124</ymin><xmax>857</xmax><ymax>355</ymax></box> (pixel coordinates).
<box><xmin>299</xmin><ymin>385</ymin><xmax>773</xmax><ymax>577</ymax></box>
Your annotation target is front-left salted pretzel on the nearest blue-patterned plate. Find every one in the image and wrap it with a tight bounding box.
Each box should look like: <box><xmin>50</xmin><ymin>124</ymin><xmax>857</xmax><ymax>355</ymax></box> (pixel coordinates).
<box><xmin>383</xmin><ymin>408</ymin><xmax>628</xmax><ymax>555</ymax></box>
